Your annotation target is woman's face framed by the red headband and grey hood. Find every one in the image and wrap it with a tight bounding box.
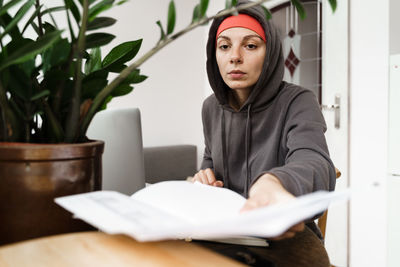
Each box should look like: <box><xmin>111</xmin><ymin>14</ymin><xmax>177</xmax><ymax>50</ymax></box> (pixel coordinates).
<box><xmin>216</xmin><ymin>27</ymin><xmax>266</xmax><ymax>94</ymax></box>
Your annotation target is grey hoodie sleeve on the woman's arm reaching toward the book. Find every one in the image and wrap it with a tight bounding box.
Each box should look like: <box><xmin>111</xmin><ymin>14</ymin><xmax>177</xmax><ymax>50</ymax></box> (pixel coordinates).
<box><xmin>266</xmin><ymin>91</ymin><xmax>336</xmax><ymax>196</ymax></box>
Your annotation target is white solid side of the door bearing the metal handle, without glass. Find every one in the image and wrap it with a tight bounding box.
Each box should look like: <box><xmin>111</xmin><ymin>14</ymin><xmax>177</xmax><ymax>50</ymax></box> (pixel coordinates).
<box><xmin>321</xmin><ymin>0</ymin><xmax>349</xmax><ymax>266</ymax></box>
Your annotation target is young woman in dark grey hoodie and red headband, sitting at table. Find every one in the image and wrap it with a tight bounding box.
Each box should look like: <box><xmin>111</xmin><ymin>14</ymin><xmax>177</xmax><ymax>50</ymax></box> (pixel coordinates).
<box><xmin>194</xmin><ymin>1</ymin><xmax>336</xmax><ymax>239</ymax></box>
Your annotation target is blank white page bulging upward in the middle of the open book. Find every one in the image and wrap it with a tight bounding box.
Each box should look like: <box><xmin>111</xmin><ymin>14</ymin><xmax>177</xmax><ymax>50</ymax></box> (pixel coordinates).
<box><xmin>131</xmin><ymin>181</ymin><xmax>246</xmax><ymax>224</ymax></box>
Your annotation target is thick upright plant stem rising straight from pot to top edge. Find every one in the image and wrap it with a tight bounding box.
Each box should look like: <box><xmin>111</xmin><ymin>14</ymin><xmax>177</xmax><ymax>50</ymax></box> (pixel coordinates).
<box><xmin>65</xmin><ymin>0</ymin><xmax>89</xmax><ymax>143</ymax></box>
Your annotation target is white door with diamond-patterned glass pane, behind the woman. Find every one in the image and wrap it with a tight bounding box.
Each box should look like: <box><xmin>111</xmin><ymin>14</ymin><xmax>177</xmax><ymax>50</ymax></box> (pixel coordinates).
<box><xmin>266</xmin><ymin>0</ymin><xmax>348</xmax><ymax>266</ymax></box>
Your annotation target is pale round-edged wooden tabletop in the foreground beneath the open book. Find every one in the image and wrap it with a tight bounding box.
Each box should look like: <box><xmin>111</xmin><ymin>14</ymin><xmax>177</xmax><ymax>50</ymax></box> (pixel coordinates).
<box><xmin>0</xmin><ymin>232</ymin><xmax>244</xmax><ymax>267</ymax></box>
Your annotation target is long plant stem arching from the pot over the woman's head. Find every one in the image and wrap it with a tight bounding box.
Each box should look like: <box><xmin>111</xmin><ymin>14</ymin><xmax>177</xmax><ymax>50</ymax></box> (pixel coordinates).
<box><xmin>79</xmin><ymin>0</ymin><xmax>269</xmax><ymax>137</ymax></box>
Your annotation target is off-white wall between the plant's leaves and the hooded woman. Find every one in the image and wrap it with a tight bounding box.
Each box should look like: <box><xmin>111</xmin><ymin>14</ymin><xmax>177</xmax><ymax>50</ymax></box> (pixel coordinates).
<box><xmin>103</xmin><ymin>0</ymin><xmax>206</xmax><ymax>168</ymax></box>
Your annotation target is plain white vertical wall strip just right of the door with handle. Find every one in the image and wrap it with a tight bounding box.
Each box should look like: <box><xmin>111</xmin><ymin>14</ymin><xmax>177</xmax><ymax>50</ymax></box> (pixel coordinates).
<box><xmin>349</xmin><ymin>0</ymin><xmax>389</xmax><ymax>267</ymax></box>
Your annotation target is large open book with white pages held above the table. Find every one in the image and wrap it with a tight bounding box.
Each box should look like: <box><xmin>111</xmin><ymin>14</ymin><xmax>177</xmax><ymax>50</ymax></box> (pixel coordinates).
<box><xmin>55</xmin><ymin>181</ymin><xmax>350</xmax><ymax>244</ymax></box>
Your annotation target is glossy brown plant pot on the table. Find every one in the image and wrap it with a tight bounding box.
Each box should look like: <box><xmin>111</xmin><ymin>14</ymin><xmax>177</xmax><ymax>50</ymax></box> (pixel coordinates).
<box><xmin>0</xmin><ymin>141</ymin><xmax>104</xmax><ymax>245</ymax></box>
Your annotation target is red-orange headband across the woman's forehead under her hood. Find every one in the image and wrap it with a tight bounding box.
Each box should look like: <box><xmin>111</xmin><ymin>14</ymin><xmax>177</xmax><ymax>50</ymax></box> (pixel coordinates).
<box><xmin>216</xmin><ymin>14</ymin><xmax>266</xmax><ymax>42</ymax></box>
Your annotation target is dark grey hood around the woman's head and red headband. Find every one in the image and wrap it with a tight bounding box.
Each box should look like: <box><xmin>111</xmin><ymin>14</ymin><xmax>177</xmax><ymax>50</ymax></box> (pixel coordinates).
<box><xmin>207</xmin><ymin>0</ymin><xmax>284</xmax><ymax>111</ymax></box>
